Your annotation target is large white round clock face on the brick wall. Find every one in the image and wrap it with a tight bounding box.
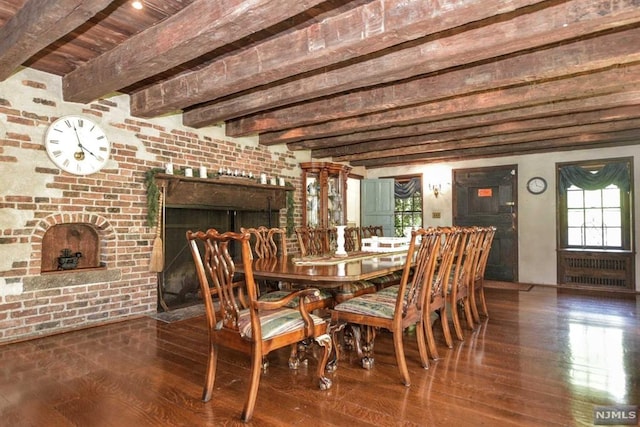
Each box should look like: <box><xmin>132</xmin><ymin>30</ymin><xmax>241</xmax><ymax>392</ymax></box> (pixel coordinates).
<box><xmin>44</xmin><ymin>116</ymin><xmax>111</xmax><ymax>175</ymax></box>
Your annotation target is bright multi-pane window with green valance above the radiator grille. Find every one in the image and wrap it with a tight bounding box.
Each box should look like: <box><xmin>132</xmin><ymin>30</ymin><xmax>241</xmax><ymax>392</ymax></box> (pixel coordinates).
<box><xmin>558</xmin><ymin>160</ymin><xmax>631</xmax><ymax>250</ymax></box>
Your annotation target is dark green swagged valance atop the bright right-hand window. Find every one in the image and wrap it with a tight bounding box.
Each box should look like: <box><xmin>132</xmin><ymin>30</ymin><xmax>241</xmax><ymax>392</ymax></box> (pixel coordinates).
<box><xmin>560</xmin><ymin>162</ymin><xmax>631</xmax><ymax>194</ymax></box>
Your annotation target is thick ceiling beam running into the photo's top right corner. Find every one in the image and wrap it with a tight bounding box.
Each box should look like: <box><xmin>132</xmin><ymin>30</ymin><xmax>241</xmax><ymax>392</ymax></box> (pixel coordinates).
<box><xmin>184</xmin><ymin>0</ymin><xmax>640</xmax><ymax>127</ymax></box>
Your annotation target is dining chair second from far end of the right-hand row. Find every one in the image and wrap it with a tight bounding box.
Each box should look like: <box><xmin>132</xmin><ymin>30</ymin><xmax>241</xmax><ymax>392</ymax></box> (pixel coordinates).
<box><xmin>443</xmin><ymin>227</ymin><xmax>481</xmax><ymax>341</ymax></box>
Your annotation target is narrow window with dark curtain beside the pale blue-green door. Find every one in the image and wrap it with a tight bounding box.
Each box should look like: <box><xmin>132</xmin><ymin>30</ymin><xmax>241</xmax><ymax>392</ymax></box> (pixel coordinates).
<box><xmin>393</xmin><ymin>176</ymin><xmax>422</xmax><ymax>237</ymax></box>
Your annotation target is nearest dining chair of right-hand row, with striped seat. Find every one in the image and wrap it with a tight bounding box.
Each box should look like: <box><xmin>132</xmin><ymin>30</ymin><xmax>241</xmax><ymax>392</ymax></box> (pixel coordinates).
<box><xmin>331</xmin><ymin>228</ymin><xmax>440</xmax><ymax>386</ymax></box>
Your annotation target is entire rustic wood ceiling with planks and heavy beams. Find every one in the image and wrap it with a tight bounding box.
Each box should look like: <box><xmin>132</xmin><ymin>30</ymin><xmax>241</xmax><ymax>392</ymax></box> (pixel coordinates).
<box><xmin>0</xmin><ymin>0</ymin><xmax>640</xmax><ymax>168</ymax></box>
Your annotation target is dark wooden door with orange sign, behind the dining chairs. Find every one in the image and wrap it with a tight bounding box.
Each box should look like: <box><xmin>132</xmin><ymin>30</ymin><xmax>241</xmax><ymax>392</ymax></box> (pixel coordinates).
<box><xmin>453</xmin><ymin>165</ymin><xmax>518</xmax><ymax>282</ymax></box>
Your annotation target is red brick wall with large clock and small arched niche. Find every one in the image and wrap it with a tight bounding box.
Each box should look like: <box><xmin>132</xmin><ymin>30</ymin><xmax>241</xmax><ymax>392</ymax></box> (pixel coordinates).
<box><xmin>0</xmin><ymin>69</ymin><xmax>301</xmax><ymax>342</ymax></box>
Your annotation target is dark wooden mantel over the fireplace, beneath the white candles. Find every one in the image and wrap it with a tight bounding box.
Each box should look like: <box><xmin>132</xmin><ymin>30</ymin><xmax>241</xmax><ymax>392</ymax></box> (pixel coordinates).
<box><xmin>155</xmin><ymin>173</ymin><xmax>293</xmax><ymax>211</ymax></box>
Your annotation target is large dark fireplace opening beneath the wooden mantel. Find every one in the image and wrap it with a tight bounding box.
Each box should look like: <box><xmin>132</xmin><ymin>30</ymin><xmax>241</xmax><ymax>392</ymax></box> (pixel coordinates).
<box><xmin>158</xmin><ymin>206</ymin><xmax>279</xmax><ymax>311</ymax></box>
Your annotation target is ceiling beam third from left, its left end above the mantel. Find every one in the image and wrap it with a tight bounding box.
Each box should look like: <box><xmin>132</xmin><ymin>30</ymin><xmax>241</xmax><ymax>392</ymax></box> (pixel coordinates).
<box><xmin>131</xmin><ymin>0</ymin><xmax>535</xmax><ymax>118</ymax></box>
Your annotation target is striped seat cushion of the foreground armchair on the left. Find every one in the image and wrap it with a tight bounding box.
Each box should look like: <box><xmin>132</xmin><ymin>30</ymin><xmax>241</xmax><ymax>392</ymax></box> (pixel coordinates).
<box><xmin>226</xmin><ymin>307</ymin><xmax>324</xmax><ymax>340</ymax></box>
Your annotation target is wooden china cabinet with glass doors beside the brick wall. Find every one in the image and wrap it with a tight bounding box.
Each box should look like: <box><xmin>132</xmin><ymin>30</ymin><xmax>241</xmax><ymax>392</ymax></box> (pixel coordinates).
<box><xmin>300</xmin><ymin>162</ymin><xmax>351</xmax><ymax>228</ymax></box>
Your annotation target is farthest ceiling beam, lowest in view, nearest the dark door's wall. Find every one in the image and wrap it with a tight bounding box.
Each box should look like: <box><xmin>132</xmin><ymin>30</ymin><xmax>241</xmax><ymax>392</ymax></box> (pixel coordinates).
<box><xmin>351</xmin><ymin>129</ymin><xmax>640</xmax><ymax>169</ymax></box>
